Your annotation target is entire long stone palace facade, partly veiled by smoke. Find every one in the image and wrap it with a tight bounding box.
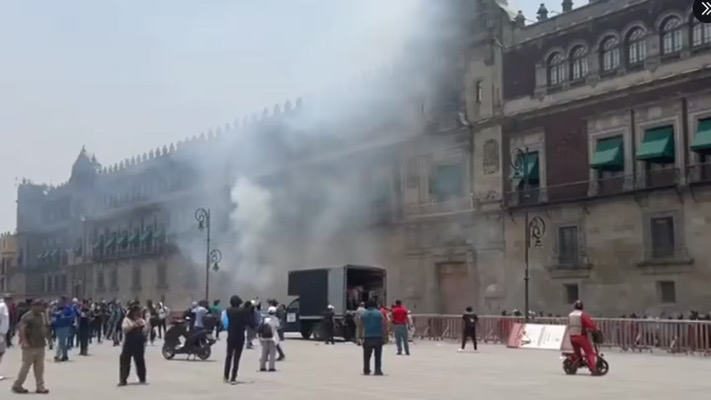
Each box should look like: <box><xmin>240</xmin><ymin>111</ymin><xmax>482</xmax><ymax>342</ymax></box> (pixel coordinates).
<box><xmin>17</xmin><ymin>0</ymin><xmax>711</xmax><ymax>315</ymax></box>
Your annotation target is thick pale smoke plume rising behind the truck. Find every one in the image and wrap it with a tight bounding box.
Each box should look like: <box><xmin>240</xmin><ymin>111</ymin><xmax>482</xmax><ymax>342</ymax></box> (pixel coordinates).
<box><xmin>163</xmin><ymin>0</ymin><xmax>472</xmax><ymax>298</ymax></box>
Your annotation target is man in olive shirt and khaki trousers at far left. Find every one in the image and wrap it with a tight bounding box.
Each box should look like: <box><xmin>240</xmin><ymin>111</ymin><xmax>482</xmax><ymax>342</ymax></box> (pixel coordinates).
<box><xmin>12</xmin><ymin>300</ymin><xmax>49</xmax><ymax>394</ymax></box>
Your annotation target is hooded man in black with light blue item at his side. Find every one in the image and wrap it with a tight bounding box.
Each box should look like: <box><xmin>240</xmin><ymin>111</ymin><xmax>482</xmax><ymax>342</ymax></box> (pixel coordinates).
<box><xmin>222</xmin><ymin>295</ymin><xmax>257</xmax><ymax>385</ymax></box>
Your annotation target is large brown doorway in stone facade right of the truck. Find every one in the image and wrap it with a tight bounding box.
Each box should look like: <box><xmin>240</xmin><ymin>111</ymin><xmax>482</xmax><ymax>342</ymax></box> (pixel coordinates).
<box><xmin>437</xmin><ymin>262</ymin><xmax>474</xmax><ymax>315</ymax></box>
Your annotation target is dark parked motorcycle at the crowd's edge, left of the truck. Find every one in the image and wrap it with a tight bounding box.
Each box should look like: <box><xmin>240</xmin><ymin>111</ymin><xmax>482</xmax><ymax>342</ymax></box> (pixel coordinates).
<box><xmin>161</xmin><ymin>320</ymin><xmax>216</xmax><ymax>361</ymax></box>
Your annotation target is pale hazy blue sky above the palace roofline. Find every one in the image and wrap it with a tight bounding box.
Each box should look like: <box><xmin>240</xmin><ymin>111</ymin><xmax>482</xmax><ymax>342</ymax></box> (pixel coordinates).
<box><xmin>0</xmin><ymin>0</ymin><xmax>544</xmax><ymax>232</ymax></box>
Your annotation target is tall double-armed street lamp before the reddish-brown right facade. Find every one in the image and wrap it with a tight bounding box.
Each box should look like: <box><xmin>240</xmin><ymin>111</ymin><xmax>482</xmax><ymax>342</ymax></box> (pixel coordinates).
<box><xmin>511</xmin><ymin>147</ymin><xmax>546</xmax><ymax>320</ymax></box>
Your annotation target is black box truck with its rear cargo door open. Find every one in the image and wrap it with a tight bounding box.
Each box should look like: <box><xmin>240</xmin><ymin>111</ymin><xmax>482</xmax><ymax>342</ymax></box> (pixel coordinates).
<box><xmin>285</xmin><ymin>264</ymin><xmax>387</xmax><ymax>340</ymax></box>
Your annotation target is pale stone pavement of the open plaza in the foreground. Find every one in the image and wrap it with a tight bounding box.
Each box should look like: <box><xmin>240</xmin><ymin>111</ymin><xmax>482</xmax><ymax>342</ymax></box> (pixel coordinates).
<box><xmin>0</xmin><ymin>340</ymin><xmax>711</xmax><ymax>400</ymax></box>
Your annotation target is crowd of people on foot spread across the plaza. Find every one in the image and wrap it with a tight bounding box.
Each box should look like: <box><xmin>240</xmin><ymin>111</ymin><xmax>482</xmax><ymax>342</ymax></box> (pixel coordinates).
<box><xmin>0</xmin><ymin>295</ymin><xmax>462</xmax><ymax>394</ymax></box>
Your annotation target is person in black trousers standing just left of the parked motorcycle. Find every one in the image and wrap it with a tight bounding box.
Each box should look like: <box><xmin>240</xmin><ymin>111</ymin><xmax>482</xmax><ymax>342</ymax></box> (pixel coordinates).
<box><xmin>119</xmin><ymin>304</ymin><xmax>149</xmax><ymax>386</ymax></box>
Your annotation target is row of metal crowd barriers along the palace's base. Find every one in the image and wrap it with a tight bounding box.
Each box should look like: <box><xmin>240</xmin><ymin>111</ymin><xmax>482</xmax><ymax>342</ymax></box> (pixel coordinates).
<box><xmin>412</xmin><ymin>314</ymin><xmax>711</xmax><ymax>356</ymax></box>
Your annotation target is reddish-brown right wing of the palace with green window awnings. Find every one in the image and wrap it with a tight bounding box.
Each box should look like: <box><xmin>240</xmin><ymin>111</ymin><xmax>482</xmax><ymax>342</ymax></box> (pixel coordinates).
<box><xmin>492</xmin><ymin>0</ymin><xmax>711</xmax><ymax>315</ymax></box>
